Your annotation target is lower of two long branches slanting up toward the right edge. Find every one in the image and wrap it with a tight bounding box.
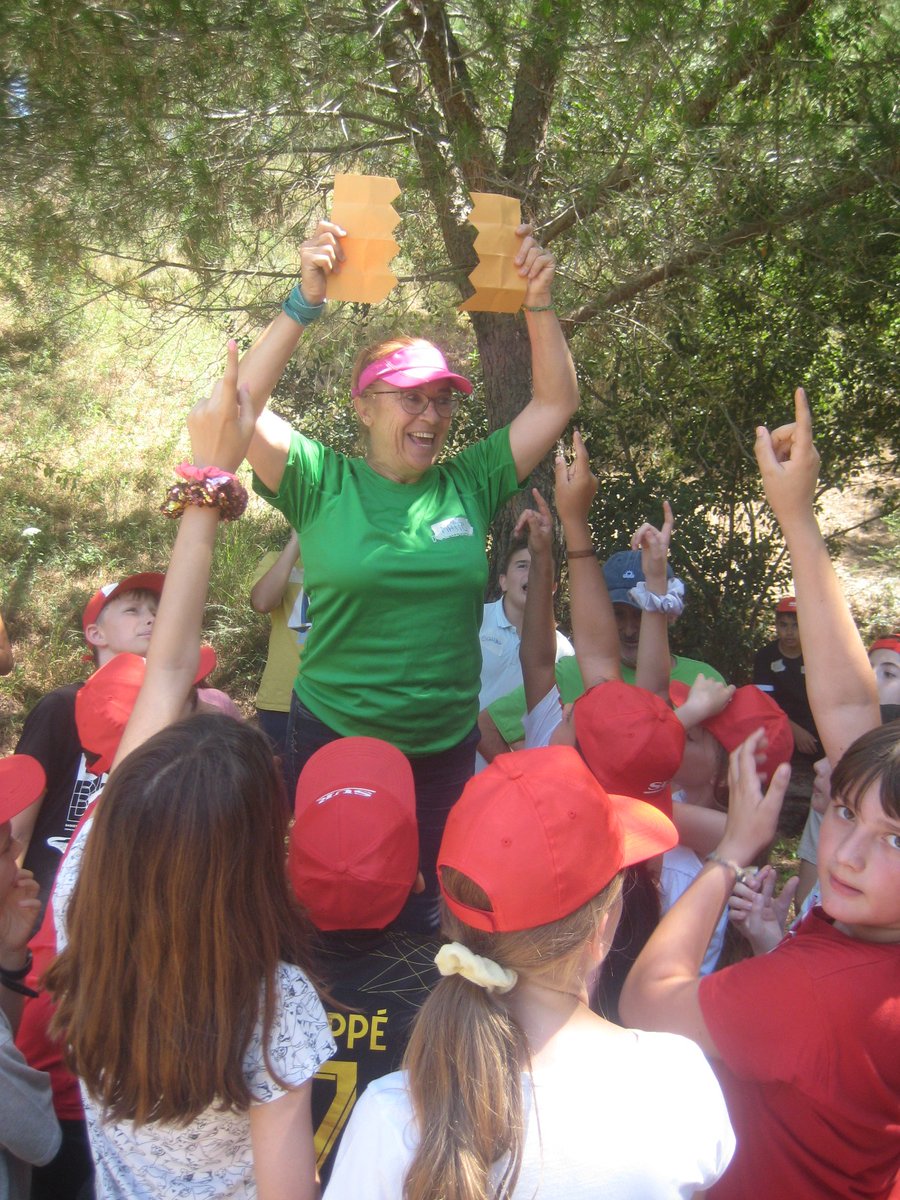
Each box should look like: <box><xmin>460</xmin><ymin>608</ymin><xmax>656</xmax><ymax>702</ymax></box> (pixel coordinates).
<box><xmin>563</xmin><ymin>150</ymin><xmax>900</xmax><ymax>332</ymax></box>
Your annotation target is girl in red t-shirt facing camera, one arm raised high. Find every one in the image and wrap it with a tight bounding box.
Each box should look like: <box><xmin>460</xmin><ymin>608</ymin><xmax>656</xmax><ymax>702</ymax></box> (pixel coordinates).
<box><xmin>622</xmin><ymin>389</ymin><xmax>900</xmax><ymax>1200</ymax></box>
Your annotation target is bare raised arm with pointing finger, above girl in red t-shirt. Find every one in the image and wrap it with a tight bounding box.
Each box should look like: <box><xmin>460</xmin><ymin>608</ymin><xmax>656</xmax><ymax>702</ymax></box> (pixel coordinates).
<box><xmin>756</xmin><ymin>388</ymin><xmax>881</xmax><ymax>763</ymax></box>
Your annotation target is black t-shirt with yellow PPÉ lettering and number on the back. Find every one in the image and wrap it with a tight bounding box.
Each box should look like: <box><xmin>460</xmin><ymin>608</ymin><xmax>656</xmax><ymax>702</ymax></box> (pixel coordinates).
<box><xmin>312</xmin><ymin>930</ymin><xmax>442</xmax><ymax>1188</ymax></box>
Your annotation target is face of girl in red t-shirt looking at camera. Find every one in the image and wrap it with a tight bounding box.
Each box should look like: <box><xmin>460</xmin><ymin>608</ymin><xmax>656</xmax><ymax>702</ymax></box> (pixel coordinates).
<box><xmin>818</xmin><ymin>782</ymin><xmax>900</xmax><ymax>942</ymax></box>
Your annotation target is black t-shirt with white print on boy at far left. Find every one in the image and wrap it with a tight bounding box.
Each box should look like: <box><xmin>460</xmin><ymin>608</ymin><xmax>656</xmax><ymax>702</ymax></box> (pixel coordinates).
<box><xmin>16</xmin><ymin>683</ymin><xmax>106</xmax><ymax>918</ymax></box>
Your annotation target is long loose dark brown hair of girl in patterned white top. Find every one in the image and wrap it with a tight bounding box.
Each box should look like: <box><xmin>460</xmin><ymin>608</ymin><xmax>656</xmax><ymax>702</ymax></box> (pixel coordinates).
<box><xmin>46</xmin><ymin>713</ymin><xmax>321</xmax><ymax>1124</ymax></box>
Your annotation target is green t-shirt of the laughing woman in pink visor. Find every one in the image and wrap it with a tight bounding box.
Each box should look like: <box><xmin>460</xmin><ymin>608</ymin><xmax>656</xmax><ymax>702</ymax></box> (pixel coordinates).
<box><xmin>253</xmin><ymin>427</ymin><xmax>518</xmax><ymax>755</ymax></box>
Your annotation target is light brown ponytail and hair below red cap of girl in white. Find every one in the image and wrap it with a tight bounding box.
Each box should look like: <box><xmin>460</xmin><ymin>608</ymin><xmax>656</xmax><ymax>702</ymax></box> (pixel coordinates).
<box><xmin>403</xmin><ymin>866</ymin><xmax>622</xmax><ymax>1200</ymax></box>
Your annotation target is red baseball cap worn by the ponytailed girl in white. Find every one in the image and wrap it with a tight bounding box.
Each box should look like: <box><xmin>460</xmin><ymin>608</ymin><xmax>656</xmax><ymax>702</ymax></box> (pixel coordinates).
<box><xmin>438</xmin><ymin>746</ymin><xmax>678</xmax><ymax>932</ymax></box>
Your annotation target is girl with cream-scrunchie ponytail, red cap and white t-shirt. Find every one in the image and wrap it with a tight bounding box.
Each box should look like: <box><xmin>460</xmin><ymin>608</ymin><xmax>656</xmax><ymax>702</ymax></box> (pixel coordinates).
<box><xmin>325</xmin><ymin>746</ymin><xmax>733</xmax><ymax>1200</ymax></box>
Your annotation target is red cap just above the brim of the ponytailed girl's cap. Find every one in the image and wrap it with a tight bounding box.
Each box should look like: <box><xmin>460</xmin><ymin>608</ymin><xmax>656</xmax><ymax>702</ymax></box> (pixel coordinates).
<box><xmin>575</xmin><ymin>680</ymin><xmax>684</xmax><ymax>817</ymax></box>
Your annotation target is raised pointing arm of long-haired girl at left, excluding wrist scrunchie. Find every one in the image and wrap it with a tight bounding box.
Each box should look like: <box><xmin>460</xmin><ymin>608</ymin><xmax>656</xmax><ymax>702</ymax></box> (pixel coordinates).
<box><xmin>113</xmin><ymin>342</ymin><xmax>253</xmax><ymax>769</ymax></box>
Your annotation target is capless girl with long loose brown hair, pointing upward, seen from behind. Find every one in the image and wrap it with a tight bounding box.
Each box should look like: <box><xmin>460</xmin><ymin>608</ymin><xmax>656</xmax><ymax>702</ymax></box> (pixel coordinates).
<box><xmin>46</xmin><ymin>342</ymin><xmax>334</xmax><ymax>1200</ymax></box>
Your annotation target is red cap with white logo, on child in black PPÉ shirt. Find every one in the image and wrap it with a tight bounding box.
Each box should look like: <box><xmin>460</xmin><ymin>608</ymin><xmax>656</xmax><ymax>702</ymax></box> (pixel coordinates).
<box><xmin>288</xmin><ymin>738</ymin><xmax>419</xmax><ymax>930</ymax></box>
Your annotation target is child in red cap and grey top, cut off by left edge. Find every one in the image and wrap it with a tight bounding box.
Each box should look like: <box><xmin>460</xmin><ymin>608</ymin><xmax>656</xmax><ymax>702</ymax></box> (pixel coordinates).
<box><xmin>0</xmin><ymin>755</ymin><xmax>60</xmax><ymax>1200</ymax></box>
